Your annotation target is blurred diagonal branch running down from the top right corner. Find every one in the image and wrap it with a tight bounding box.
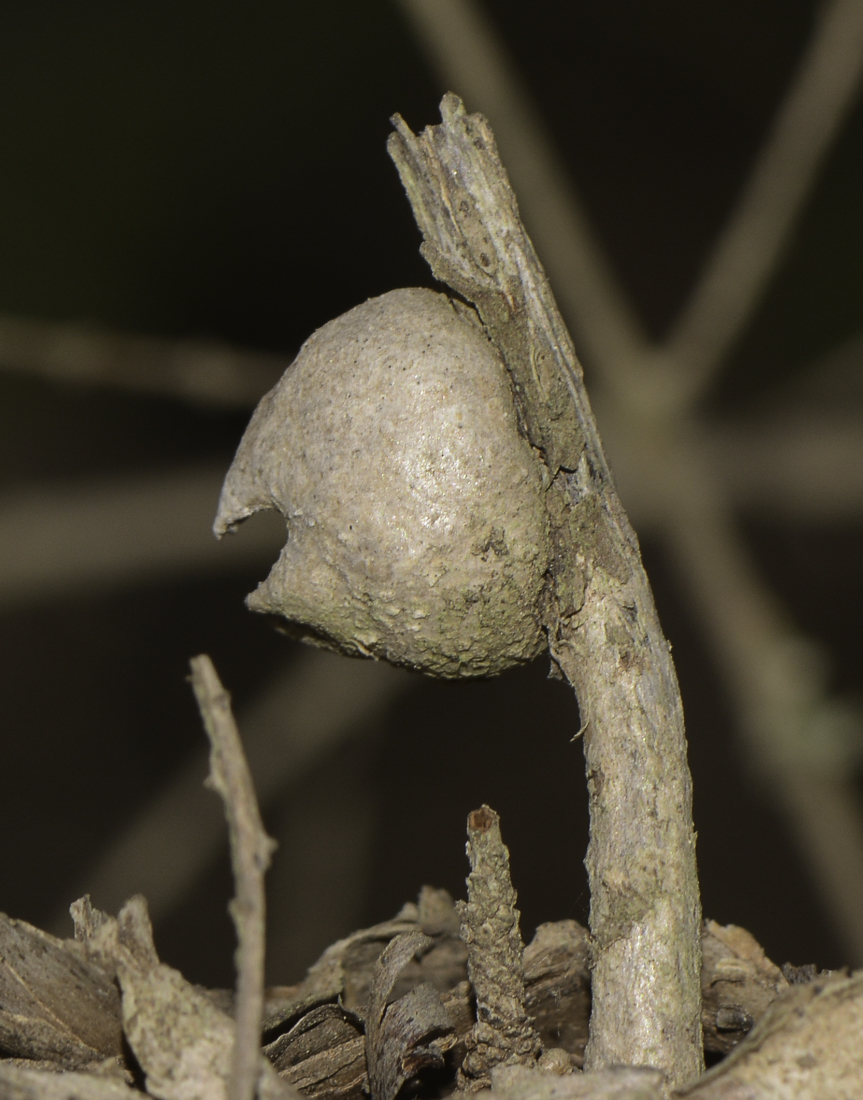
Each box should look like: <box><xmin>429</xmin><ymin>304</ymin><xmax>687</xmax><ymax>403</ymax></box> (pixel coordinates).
<box><xmin>663</xmin><ymin>0</ymin><xmax>863</xmax><ymax>403</ymax></box>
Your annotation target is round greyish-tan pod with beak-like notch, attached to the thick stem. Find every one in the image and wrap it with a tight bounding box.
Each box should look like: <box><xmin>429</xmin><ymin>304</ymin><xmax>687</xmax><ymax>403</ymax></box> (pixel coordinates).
<box><xmin>214</xmin><ymin>289</ymin><xmax>550</xmax><ymax>677</ymax></box>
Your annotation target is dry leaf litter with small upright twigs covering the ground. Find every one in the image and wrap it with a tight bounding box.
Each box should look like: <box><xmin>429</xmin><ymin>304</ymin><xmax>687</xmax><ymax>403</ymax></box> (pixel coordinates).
<box><xmin>0</xmin><ymin>657</ymin><xmax>863</xmax><ymax>1100</ymax></box>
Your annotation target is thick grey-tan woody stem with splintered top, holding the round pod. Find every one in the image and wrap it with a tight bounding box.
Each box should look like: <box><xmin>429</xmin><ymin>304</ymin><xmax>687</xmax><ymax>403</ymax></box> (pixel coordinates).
<box><xmin>389</xmin><ymin>95</ymin><xmax>702</xmax><ymax>1084</ymax></box>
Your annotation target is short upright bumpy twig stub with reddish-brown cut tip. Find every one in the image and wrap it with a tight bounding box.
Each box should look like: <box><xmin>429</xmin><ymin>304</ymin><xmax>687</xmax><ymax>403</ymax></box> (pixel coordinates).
<box><xmin>457</xmin><ymin>805</ymin><xmax>542</xmax><ymax>1091</ymax></box>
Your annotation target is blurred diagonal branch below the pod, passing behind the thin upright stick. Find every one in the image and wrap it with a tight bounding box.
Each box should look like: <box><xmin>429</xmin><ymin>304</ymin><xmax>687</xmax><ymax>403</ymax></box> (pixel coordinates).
<box><xmin>51</xmin><ymin>650</ymin><xmax>416</xmax><ymax>935</ymax></box>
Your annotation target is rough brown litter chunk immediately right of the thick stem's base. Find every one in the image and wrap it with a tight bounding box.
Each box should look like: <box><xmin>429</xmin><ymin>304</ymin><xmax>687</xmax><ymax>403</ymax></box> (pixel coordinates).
<box><xmin>701</xmin><ymin>921</ymin><xmax>788</xmax><ymax>1054</ymax></box>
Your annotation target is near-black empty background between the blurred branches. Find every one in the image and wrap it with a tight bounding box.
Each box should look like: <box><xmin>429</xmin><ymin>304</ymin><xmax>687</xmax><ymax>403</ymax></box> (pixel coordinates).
<box><xmin>0</xmin><ymin>0</ymin><xmax>863</xmax><ymax>985</ymax></box>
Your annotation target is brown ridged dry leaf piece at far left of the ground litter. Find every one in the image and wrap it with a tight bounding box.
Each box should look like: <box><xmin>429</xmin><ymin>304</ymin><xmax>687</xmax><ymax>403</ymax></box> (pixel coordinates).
<box><xmin>0</xmin><ymin>914</ymin><xmax>122</xmax><ymax>1069</ymax></box>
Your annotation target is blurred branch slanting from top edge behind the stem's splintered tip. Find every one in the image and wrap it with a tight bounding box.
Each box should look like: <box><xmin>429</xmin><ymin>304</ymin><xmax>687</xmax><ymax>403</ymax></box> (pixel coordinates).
<box><xmin>391</xmin><ymin>0</ymin><xmax>649</xmax><ymax>371</ymax></box>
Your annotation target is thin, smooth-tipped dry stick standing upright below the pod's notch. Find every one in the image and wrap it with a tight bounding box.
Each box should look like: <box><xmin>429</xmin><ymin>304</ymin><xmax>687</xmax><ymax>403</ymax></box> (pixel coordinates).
<box><xmin>190</xmin><ymin>653</ymin><xmax>275</xmax><ymax>1100</ymax></box>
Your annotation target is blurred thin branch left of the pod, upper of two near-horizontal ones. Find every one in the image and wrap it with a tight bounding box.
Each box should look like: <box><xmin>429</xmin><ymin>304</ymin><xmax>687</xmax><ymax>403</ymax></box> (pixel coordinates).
<box><xmin>0</xmin><ymin>316</ymin><xmax>290</xmax><ymax>408</ymax></box>
